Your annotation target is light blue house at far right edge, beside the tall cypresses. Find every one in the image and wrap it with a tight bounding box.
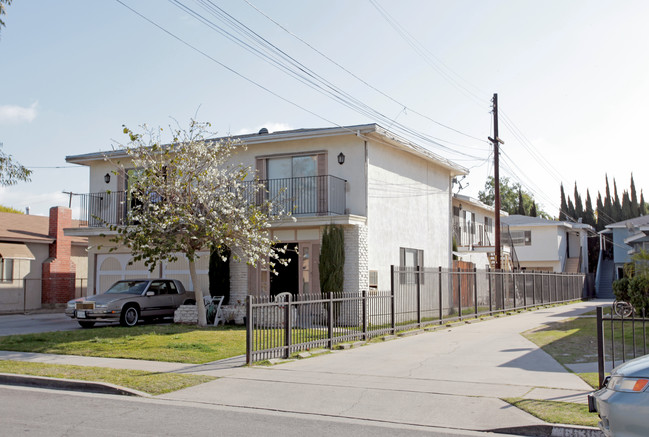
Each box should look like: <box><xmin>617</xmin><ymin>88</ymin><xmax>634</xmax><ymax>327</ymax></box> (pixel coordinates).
<box><xmin>600</xmin><ymin>215</ymin><xmax>649</xmax><ymax>279</ymax></box>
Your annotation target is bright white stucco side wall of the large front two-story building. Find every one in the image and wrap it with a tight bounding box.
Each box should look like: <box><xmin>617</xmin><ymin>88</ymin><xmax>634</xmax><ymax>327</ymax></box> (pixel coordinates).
<box><xmin>367</xmin><ymin>142</ymin><xmax>451</xmax><ymax>289</ymax></box>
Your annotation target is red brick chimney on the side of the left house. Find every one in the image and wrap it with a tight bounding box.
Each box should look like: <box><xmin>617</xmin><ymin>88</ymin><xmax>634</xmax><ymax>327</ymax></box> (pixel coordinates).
<box><xmin>42</xmin><ymin>206</ymin><xmax>76</xmax><ymax>306</ymax></box>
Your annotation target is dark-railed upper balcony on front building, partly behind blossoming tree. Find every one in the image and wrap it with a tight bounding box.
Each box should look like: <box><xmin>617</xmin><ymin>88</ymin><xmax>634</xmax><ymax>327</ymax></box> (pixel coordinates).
<box><xmin>76</xmin><ymin>175</ymin><xmax>347</xmax><ymax>228</ymax></box>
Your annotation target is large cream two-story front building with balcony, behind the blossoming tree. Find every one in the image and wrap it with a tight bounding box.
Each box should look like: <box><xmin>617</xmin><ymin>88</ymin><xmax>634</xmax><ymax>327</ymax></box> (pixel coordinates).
<box><xmin>66</xmin><ymin>124</ymin><xmax>467</xmax><ymax>318</ymax></box>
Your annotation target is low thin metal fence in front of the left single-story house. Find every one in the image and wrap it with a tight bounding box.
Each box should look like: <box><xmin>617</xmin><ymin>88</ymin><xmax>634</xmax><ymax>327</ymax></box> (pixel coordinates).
<box><xmin>0</xmin><ymin>278</ymin><xmax>88</xmax><ymax>313</ymax></box>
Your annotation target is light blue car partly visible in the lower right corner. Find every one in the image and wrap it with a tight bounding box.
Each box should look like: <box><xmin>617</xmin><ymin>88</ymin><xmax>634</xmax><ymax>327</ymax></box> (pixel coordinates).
<box><xmin>588</xmin><ymin>355</ymin><xmax>649</xmax><ymax>437</ymax></box>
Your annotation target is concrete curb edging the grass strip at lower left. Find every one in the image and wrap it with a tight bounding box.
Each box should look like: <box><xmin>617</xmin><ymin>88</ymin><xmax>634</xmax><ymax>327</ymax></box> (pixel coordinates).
<box><xmin>0</xmin><ymin>373</ymin><xmax>151</xmax><ymax>397</ymax></box>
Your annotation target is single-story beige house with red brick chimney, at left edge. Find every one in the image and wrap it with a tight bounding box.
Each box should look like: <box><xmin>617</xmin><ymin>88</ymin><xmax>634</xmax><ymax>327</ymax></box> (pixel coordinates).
<box><xmin>0</xmin><ymin>207</ymin><xmax>88</xmax><ymax>312</ymax></box>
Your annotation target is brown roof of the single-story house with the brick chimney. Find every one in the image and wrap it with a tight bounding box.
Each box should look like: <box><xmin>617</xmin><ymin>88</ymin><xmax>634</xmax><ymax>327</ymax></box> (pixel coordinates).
<box><xmin>0</xmin><ymin>212</ymin><xmax>88</xmax><ymax>245</ymax></box>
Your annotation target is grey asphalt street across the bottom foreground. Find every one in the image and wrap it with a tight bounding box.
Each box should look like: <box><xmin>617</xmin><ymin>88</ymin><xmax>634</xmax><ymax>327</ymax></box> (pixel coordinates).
<box><xmin>0</xmin><ymin>386</ymin><xmax>506</xmax><ymax>437</ymax></box>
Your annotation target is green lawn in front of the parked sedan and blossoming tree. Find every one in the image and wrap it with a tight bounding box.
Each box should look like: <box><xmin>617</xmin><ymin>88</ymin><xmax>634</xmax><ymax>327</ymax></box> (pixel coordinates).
<box><xmin>0</xmin><ymin>324</ymin><xmax>246</xmax><ymax>364</ymax></box>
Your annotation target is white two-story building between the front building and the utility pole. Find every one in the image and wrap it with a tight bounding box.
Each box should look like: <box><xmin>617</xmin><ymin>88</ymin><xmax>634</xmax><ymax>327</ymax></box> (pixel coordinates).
<box><xmin>453</xmin><ymin>194</ymin><xmax>509</xmax><ymax>269</ymax></box>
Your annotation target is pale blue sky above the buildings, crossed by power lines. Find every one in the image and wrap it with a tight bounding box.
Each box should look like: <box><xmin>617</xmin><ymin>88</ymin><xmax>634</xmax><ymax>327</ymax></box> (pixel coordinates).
<box><xmin>0</xmin><ymin>0</ymin><xmax>649</xmax><ymax>215</ymax></box>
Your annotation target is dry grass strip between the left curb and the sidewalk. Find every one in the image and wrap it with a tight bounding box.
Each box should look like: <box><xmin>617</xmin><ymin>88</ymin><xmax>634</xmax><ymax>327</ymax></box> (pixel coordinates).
<box><xmin>0</xmin><ymin>360</ymin><xmax>216</xmax><ymax>395</ymax></box>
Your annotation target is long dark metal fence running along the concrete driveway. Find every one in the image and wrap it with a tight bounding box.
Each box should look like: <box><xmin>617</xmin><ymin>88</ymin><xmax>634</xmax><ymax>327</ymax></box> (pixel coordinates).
<box><xmin>246</xmin><ymin>266</ymin><xmax>584</xmax><ymax>363</ymax></box>
